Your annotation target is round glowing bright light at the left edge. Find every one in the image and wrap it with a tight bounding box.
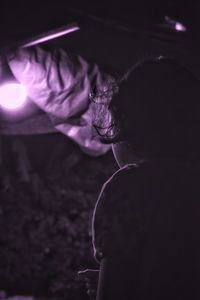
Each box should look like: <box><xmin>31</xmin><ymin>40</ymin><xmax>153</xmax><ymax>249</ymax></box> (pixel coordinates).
<box><xmin>0</xmin><ymin>83</ymin><xmax>27</xmax><ymax>109</ymax></box>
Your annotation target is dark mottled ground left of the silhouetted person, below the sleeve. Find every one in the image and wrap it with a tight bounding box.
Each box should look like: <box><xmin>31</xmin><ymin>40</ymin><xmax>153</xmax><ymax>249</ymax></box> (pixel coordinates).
<box><xmin>0</xmin><ymin>134</ymin><xmax>117</xmax><ymax>300</ymax></box>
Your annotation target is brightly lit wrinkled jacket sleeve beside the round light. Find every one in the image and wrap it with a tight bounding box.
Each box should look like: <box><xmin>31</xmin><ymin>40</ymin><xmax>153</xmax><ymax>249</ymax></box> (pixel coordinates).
<box><xmin>7</xmin><ymin>47</ymin><xmax>115</xmax><ymax>156</ymax></box>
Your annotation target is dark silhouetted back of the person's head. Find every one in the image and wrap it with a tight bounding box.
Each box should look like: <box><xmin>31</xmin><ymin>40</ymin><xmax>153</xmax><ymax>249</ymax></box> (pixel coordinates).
<box><xmin>110</xmin><ymin>58</ymin><xmax>200</xmax><ymax>160</ymax></box>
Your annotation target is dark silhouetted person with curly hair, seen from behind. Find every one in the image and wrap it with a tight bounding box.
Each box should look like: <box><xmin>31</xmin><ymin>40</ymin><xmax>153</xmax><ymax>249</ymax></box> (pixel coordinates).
<box><xmin>93</xmin><ymin>57</ymin><xmax>200</xmax><ymax>300</ymax></box>
